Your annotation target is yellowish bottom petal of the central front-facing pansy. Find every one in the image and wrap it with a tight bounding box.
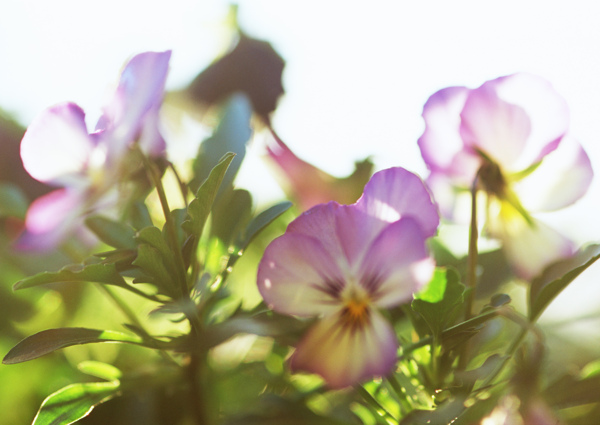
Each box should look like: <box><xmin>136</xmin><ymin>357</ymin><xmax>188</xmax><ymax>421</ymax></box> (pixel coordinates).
<box><xmin>290</xmin><ymin>310</ymin><xmax>398</xmax><ymax>388</ymax></box>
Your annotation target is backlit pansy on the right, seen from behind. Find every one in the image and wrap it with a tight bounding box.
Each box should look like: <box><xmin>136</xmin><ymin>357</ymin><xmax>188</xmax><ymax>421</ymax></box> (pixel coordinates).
<box><xmin>418</xmin><ymin>73</ymin><xmax>593</xmax><ymax>279</ymax></box>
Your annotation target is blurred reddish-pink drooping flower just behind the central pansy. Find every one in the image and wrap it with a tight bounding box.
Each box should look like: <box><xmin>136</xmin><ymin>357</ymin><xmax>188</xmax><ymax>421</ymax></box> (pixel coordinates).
<box><xmin>267</xmin><ymin>133</ymin><xmax>373</xmax><ymax>211</ymax></box>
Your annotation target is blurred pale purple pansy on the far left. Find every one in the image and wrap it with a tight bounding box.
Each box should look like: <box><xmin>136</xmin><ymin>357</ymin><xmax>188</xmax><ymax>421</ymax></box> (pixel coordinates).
<box><xmin>17</xmin><ymin>51</ymin><xmax>171</xmax><ymax>250</ymax></box>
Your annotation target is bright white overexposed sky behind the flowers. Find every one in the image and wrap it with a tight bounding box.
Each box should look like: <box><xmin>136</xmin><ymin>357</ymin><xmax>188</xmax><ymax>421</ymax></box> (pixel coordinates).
<box><xmin>0</xmin><ymin>0</ymin><xmax>600</xmax><ymax>322</ymax></box>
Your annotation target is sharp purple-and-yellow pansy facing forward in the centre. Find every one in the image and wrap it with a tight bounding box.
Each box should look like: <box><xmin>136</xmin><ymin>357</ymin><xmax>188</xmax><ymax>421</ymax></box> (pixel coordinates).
<box><xmin>258</xmin><ymin>168</ymin><xmax>439</xmax><ymax>388</ymax></box>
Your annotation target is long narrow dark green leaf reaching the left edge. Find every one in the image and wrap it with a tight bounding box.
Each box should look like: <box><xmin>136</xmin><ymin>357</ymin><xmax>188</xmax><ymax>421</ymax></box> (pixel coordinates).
<box><xmin>2</xmin><ymin>328</ymin><xmax>144</xmax><ymax>364</ymax></box>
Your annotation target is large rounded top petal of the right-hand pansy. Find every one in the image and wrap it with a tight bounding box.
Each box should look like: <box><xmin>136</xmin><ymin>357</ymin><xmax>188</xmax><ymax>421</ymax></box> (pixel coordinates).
<box><xmin>461</xmin><ymin>73</ymin><xmax>569</xmax><ymax>171</ymax></box>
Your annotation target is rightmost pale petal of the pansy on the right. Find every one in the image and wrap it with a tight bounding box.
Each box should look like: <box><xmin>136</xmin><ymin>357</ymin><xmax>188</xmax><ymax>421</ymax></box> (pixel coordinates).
<box><xmin>514</xmin><ymin>138</ymin><xmax>594</xmax><ymax>212</ymax></box>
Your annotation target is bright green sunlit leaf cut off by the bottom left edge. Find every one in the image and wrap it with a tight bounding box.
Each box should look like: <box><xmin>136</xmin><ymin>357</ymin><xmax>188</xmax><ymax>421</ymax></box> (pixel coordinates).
<box><xmin>32</xmin><ymin>381</ymin><xmax>120</xmax><ymax>425</ymax></box>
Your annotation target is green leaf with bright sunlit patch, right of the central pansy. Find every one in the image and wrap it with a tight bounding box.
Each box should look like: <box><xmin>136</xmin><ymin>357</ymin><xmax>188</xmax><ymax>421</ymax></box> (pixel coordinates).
<box><xmin>412</xmin><ymin>269</ymin><xmax>465</xmax><ymax>337</ymax></box>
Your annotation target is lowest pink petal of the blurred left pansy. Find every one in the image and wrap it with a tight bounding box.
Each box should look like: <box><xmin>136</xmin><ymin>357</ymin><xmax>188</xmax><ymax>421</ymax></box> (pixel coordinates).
<box><xmin>16</xmin><ymin>189</ymin><xmax>85</xmax><ymax>251</ymax></box>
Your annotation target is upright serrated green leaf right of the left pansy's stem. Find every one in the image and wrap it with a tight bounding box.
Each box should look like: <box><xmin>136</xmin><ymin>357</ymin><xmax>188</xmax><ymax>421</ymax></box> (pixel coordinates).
<box><xmin>182</xmin><ymin>152</ymin><xmax>235</xmax><ymax>240</ymax></box>
